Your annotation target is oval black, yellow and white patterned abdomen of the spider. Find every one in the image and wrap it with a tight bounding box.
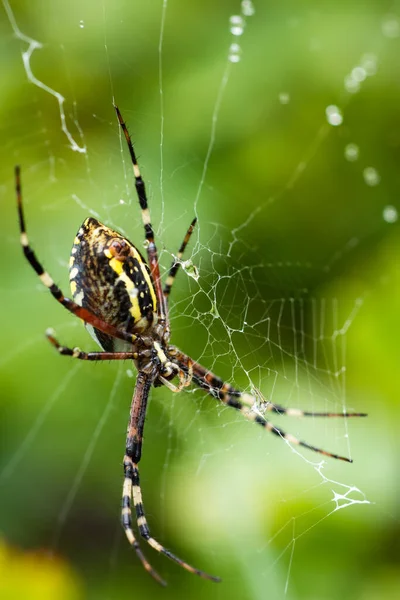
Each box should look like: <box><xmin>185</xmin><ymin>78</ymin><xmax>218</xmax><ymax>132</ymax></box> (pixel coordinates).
<box><xmin>69</xmin><ymin>217</ymin><xmax>157</xmax><ymax>351</ymax></box>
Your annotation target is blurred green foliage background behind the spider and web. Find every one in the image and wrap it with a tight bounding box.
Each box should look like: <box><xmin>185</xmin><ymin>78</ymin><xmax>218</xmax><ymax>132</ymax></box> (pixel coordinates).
<box><xmin>0</xmin><ymin>0</ymin><xmax>400</xmax><ymax>600</ymax></box>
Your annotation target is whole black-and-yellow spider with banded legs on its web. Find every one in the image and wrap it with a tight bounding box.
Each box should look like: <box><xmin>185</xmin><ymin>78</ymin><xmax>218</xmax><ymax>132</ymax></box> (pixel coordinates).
<box><xmin>15</xmin><ymin>106</ymin><xmax>366</xmax><ymax>585</ymax></box>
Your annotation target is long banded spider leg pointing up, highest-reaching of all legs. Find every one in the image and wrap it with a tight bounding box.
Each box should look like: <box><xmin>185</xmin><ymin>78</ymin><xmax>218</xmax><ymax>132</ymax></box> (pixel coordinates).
<box><xmin>114</xmin><ymin>105</ymin><xmax>168</xmax><ymax>324</ymax></box>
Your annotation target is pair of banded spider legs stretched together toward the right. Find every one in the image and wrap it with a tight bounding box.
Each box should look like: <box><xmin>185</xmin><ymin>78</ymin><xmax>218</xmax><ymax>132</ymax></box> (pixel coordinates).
<box><xmin>168</xmin><ymin>347</ymin><xmax>366</xmax><ymax>462</ymax></box>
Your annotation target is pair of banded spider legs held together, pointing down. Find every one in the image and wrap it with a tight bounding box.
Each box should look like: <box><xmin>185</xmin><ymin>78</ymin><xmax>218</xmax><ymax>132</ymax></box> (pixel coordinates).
<box><xmin>122</xmin><ymin>371</ymin><xmax>220</xmax><ymax>581</ymax></box>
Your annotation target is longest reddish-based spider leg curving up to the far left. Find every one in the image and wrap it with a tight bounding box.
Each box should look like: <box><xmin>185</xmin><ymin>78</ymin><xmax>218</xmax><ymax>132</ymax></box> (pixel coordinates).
<box><xmin>15</xmin><ymin>166</ymin><xmax>142</xmax><ymax>344</ymax></box>
